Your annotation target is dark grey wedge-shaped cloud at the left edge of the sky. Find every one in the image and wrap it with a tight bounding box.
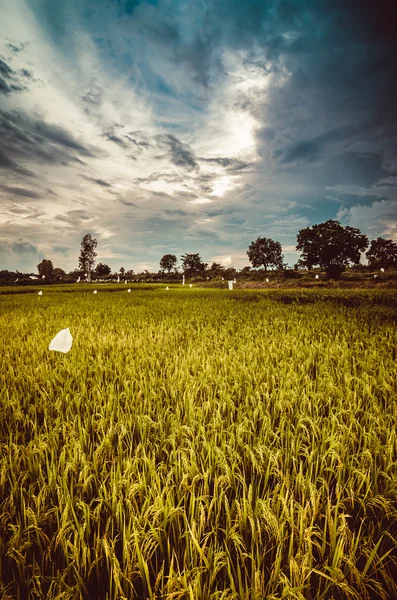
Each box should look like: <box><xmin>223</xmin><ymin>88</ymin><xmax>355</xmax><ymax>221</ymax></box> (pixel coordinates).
<box><xmin>0</xmin><ymin>109</ymin><xmax>98</xmax><ymax>175</ymax></box>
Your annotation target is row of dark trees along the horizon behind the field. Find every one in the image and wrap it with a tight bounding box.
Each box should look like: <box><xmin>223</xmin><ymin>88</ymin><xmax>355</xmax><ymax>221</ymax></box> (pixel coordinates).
<box><xmin>0</xmin><ymin>220</ymin><xmax>397</xmax><ymax>282</ymax></box>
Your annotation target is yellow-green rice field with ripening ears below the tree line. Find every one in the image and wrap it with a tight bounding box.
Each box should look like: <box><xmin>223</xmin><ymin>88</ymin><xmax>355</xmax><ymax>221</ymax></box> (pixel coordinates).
<box><xmin>0</xmin><ymin>286</ymin><xmax>397</xmax><ymax>600</ymax></box>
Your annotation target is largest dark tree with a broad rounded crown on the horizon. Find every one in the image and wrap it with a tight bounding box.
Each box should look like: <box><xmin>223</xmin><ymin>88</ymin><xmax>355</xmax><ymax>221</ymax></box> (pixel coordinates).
<box><xmin>296</xmin><ymin>220</ymin><xmax>368</xmax><ymax>279</ymax></box>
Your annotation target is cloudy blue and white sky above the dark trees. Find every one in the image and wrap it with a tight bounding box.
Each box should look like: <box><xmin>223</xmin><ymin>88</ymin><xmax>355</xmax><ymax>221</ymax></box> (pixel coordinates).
<box><xmin>0</xmin><ymin>0</ymin><xmax>397</xmax><ymax>272</ymax></box>
